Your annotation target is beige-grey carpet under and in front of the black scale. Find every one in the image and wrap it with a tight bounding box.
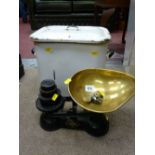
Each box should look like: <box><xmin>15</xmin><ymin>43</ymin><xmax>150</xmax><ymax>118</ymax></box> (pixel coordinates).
<box><xmin>19</xmin><ymin>69</ymin><xmax>135</xmax><ymax>155</ymax></box>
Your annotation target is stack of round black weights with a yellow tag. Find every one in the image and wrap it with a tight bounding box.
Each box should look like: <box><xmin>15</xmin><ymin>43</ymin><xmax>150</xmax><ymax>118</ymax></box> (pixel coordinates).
<box><xmin>37</xmin><ymin>80</ymin><xmax>64</xmax><ymax>112</ymax></box>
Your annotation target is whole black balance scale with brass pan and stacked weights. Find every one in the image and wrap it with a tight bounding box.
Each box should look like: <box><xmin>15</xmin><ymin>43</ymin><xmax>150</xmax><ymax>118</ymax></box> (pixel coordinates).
<box><xmin>36</xmin><ymin>69</ymin><xmax>135</xmax><ymax>137</ymax></box>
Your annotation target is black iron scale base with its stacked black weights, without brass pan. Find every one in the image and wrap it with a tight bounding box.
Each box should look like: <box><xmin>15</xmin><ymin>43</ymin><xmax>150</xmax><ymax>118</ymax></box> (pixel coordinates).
<box><xmin>36</xmin><ymin>80</ymin><xmax>109</xmax><ymax>137</ymax></box>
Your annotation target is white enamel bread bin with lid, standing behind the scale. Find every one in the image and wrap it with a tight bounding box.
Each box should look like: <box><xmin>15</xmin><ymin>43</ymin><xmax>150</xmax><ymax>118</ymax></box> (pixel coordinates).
<box><xmin>30</xmin><ymin>26</ymin><xmax>111</xmax><ymax>95</ymax></box>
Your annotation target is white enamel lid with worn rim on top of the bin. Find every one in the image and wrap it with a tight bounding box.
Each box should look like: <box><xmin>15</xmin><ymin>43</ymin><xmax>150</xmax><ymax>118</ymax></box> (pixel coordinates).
<box><xmin>30</xmin><ymin>26</ymin><xmax>111</xmax><ymax>44</ymax></box>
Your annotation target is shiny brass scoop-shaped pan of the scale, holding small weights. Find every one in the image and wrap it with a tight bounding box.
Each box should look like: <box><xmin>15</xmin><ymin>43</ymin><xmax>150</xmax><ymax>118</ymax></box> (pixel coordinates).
<box><xmin>68</xmin><ymin>69</ymin><xmax>135</xmax><ymax>113</ymax></box>
